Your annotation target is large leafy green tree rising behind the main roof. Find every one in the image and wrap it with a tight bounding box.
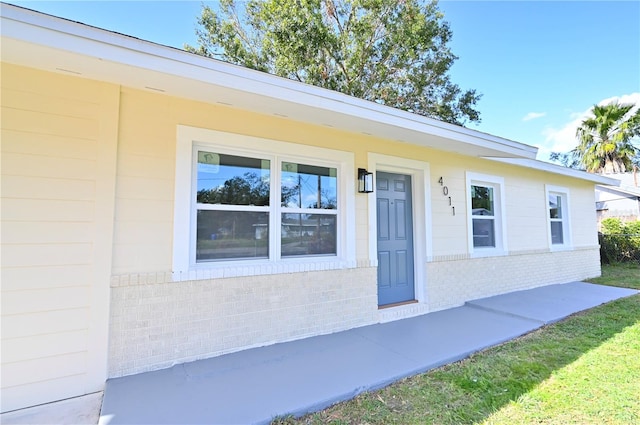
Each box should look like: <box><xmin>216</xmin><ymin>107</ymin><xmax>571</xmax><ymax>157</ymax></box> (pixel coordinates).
<box><xmin>185</xmin><ymin>0</ymin><xmax>480</xmax><ymax>124</ymax></box>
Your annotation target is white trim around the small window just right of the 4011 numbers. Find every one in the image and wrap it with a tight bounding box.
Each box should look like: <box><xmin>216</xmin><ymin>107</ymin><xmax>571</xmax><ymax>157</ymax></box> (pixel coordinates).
<box><xmin>466</xmin><ymin>171</ymin><xmax>508</xmax><ymax>257</ymax></box>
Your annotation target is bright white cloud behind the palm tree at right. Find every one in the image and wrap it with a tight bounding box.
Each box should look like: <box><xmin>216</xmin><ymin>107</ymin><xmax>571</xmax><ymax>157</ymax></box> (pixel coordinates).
<box><xmin>539</xmin><ymin>93</ymin><xmax>640</xmax><ymax>154</ymax></box>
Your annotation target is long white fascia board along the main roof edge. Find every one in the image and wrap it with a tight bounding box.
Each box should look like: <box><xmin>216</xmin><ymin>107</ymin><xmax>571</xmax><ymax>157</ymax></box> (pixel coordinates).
<box><xmin>1</xmin><ymin>4</ymin><xmax>537</xmax><ymax>159</ymax></box>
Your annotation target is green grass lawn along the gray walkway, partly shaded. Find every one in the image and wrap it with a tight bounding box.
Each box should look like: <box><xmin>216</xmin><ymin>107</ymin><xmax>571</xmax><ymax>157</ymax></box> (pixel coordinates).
<box><xmin>274</xmin><ymin>264</ymin><xmax>640</xmax><ymax>425</ymax></box>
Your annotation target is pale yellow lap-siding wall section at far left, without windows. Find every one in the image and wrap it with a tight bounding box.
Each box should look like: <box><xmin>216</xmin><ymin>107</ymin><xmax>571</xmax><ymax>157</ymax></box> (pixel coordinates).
<box><xmin>0</xmin><ymin>63</ymin><xmax>119</xmax><ymax>412</ymax></box>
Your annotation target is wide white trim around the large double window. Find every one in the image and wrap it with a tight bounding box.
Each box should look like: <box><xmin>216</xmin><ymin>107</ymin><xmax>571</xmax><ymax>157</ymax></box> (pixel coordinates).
<box><xmin>172</xmin><ymin>125</ymin><xmax>356</xmax><ymax>280</ymax></box>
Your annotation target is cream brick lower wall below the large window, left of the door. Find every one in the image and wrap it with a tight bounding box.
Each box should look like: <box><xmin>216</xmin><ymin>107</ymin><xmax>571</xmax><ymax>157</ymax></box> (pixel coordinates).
<box><xmin>109</xmin><ymin>267</ymin><xmax>378</xmax><ymax>377</ymax></box>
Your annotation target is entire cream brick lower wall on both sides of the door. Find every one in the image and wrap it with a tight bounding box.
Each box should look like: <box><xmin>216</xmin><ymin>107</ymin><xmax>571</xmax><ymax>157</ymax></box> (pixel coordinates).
<box><xmin>109</xmin><ymin>247</ymin><xmax>600</xmax><ymax>377</ymax></box>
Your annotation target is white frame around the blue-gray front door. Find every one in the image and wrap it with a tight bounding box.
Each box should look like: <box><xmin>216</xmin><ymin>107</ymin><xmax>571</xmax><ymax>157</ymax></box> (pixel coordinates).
<box><xmin>368</xmin><ymin>153</ymin><xmax>432</xmax><ymax>303</ymax></box>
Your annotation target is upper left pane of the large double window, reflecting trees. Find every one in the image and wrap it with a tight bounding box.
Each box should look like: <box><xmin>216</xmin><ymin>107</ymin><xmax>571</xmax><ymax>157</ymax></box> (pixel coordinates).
<box><xmin>196</xmin><ymin>151</ymin><xmax>270</xmax><ymax>206</ymax></box>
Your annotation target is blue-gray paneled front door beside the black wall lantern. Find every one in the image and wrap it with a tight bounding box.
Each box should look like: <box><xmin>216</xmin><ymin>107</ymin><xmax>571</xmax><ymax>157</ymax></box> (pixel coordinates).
<box><xmin>376</xmin><ymin>172</ymin><xmax>415</xmax><ymax>306</ymax></box>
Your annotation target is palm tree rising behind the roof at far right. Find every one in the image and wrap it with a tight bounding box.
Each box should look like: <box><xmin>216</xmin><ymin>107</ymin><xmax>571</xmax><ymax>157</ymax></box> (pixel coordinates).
<box><xmin>572</xmin><ymin>102</ymin><xmax>640</xmax><ymax>173</ymax></box>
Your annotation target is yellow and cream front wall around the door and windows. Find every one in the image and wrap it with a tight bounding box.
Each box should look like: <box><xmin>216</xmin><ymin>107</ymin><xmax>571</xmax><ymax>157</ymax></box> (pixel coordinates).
<box><xmin>109</xmin><ymin>83</ymin><xmax>600</xmax><ymax>377</ymax></box>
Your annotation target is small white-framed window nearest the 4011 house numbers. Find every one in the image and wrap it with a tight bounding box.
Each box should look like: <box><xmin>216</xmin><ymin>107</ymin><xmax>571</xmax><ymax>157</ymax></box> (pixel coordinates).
<box><xmin>467</xmin><ymin>173</ymin><xmax>506</xmax><ymax>256</ymax></box>
